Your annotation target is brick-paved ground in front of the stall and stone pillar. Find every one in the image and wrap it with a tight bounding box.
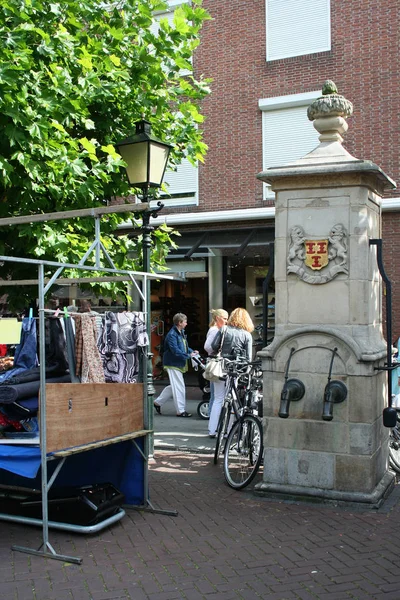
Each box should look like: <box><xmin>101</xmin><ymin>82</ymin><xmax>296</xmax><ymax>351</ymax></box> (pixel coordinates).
<box><xmin>0</xmin><ymin>451</ymin><xmax>400</xmax><ymax>600</ymax></box>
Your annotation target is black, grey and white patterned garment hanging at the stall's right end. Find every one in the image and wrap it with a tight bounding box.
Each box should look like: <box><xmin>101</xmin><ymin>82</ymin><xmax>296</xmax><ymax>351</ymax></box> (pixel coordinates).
<box><xmin>98</xmin><ymin>311</ymin><xmax>148</xmax><ymax>383</ymax></box>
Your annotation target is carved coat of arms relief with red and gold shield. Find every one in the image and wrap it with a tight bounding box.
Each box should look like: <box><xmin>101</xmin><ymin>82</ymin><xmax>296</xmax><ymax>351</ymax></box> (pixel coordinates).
<box><xmin>287</xmin><ymin>223</ymin><xmax>349</xmax><ymax>284</ymax></box>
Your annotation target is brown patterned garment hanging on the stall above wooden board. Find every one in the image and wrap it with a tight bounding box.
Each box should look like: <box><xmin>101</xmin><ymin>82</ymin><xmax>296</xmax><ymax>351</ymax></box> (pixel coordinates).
<box><xmin>72</xmin><ymin>313</ymin><xmax>106</xmax><ymax>383</ymax></box>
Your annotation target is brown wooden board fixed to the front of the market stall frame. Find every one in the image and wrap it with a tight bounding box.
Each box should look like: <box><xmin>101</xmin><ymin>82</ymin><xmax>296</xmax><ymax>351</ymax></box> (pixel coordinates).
<box><xmin>46</xmin><ymin>383</ymin><xmax>143</xmax><ymax>452</ymax></box>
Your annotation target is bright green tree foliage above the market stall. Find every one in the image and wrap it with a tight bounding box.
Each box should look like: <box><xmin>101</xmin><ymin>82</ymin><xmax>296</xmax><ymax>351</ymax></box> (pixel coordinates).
<box><xmin>0</xmin><ymin>0</ymin><xmax>209</xmax><ymax>308</ymax></box>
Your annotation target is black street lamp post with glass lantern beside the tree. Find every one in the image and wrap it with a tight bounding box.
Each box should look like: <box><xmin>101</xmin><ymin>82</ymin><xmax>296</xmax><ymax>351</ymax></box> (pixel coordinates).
<box><xmin>115</xmin><ymin>119</ymin><xmax>172</xmax><ymax>440</ymax></box>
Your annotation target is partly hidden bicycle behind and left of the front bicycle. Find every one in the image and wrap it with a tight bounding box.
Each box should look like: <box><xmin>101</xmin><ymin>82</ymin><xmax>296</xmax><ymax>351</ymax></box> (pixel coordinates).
<box><xmin>214</xmin><ymin>358</ymin><xmax>249</xmax><ymax>465</ymax></box>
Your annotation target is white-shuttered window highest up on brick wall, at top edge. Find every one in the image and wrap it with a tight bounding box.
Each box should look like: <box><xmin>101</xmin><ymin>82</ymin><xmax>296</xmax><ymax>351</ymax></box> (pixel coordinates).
<box><xmin>265</xmin><ymin>0</ymin><xmax>331</xmax><ymax>61</ymax></box>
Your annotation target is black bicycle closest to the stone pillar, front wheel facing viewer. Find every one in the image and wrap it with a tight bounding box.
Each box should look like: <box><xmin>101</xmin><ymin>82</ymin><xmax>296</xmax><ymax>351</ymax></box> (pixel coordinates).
<box><xmin>224</xmin><ymin>363</ymin><xmax>264</xmax><ymax>490</ymax></box>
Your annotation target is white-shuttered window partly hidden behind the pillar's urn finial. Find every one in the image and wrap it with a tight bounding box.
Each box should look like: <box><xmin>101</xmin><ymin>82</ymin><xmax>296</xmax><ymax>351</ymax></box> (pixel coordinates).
<box><xmin>258</xmin><ymin>91</ymin><xmax>321</xmax><ymax>199</ymax></box>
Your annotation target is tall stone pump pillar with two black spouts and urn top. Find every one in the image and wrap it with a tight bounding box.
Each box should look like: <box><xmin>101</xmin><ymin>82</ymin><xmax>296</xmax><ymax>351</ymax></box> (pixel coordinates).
<box><xmin>256</xmin><ymin>82</ymin><xmax>395</xmax><ymax>505</ymax></box>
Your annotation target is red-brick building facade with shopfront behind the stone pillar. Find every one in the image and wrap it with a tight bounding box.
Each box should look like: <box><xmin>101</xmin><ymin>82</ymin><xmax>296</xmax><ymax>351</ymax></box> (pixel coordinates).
<box><xmin>130</xmin><ymin>0</ymin><xmax>400</xmax><ymax>352</ymax></box>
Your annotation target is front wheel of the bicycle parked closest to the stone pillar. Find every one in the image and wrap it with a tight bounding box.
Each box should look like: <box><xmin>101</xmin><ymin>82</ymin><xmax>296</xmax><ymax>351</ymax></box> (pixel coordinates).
<box><xmin>224</xmin><ymin>415</ymin><xmax>263</xmax><ymax>490</ymax></box>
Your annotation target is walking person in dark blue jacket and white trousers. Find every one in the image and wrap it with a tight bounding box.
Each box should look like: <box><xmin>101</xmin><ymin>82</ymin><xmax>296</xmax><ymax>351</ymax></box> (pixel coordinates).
<box><xmin>154</xmin><ymin>313</ymin><xmax>199</xmax><ymax>417</ymax></box>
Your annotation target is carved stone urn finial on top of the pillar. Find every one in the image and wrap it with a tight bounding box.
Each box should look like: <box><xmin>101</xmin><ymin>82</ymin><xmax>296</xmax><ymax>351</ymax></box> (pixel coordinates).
<box><xmin>307</xmin><ymin>79</ymin><xmax>353</xmax><ymax>144</ymax></box>
